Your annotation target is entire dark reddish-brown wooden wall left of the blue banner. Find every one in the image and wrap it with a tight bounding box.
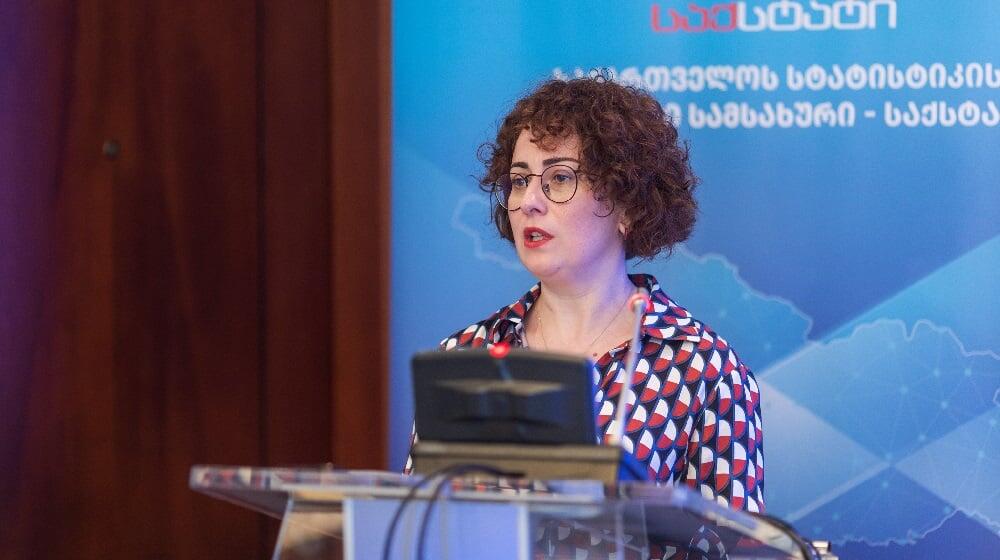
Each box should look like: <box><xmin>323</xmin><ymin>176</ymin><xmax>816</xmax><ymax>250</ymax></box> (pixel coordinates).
<box><xmin>0</xmin><ymin>0</ymin><xmax>390</xmax><ymax>558</ymax></box>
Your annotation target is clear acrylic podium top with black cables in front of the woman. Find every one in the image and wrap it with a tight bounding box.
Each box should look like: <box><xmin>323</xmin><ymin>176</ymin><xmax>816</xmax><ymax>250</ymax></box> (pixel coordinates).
<box><xmin>190</xmin><ymin>465</ymin><xmax>812</xmax><ymax>560</ymax></box>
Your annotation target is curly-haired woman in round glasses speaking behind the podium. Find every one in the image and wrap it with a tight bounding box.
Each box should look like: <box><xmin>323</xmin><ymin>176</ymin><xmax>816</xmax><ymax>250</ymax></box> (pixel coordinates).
<box><xmin>426</xmin><ymin>78</ymin><xmax>764</xmax><ymax>512</ymax></box>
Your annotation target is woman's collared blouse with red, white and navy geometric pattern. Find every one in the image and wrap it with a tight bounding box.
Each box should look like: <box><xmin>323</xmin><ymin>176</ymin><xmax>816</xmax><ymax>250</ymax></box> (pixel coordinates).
<box><xmin>430</xmin><ymin>274</ymin><xmax>764</xmax><ymax>512</ymax></box>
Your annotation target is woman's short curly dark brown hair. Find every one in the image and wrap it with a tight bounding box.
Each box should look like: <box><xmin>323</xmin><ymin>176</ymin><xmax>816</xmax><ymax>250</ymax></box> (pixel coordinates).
<box><xmin>479</xmin><ymin>76</ymin><xmax>698</xmax><ymax>259</ymax></box>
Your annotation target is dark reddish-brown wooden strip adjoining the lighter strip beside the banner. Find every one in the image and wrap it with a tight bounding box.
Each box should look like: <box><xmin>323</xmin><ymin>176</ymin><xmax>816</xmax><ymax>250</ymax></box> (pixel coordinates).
<box><xmin>258</xmin><ymin>2</ymin><xmax>333</xmax><ymax>465</ymax></box>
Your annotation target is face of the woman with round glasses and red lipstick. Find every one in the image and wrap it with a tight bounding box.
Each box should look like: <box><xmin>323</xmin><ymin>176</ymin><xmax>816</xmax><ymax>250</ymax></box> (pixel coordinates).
<box><xmin>508</xmin><ymin>129</ymin><xmax>625</xmax><ymax>282</ymax></box>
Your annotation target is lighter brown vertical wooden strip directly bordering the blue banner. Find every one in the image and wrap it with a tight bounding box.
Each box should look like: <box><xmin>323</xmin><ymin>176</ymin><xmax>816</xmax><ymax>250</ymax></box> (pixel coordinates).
<box><xmin>330</xmin><ymin>0</ymin><xmax>390</xmax><ymax>468</ymax></box>
